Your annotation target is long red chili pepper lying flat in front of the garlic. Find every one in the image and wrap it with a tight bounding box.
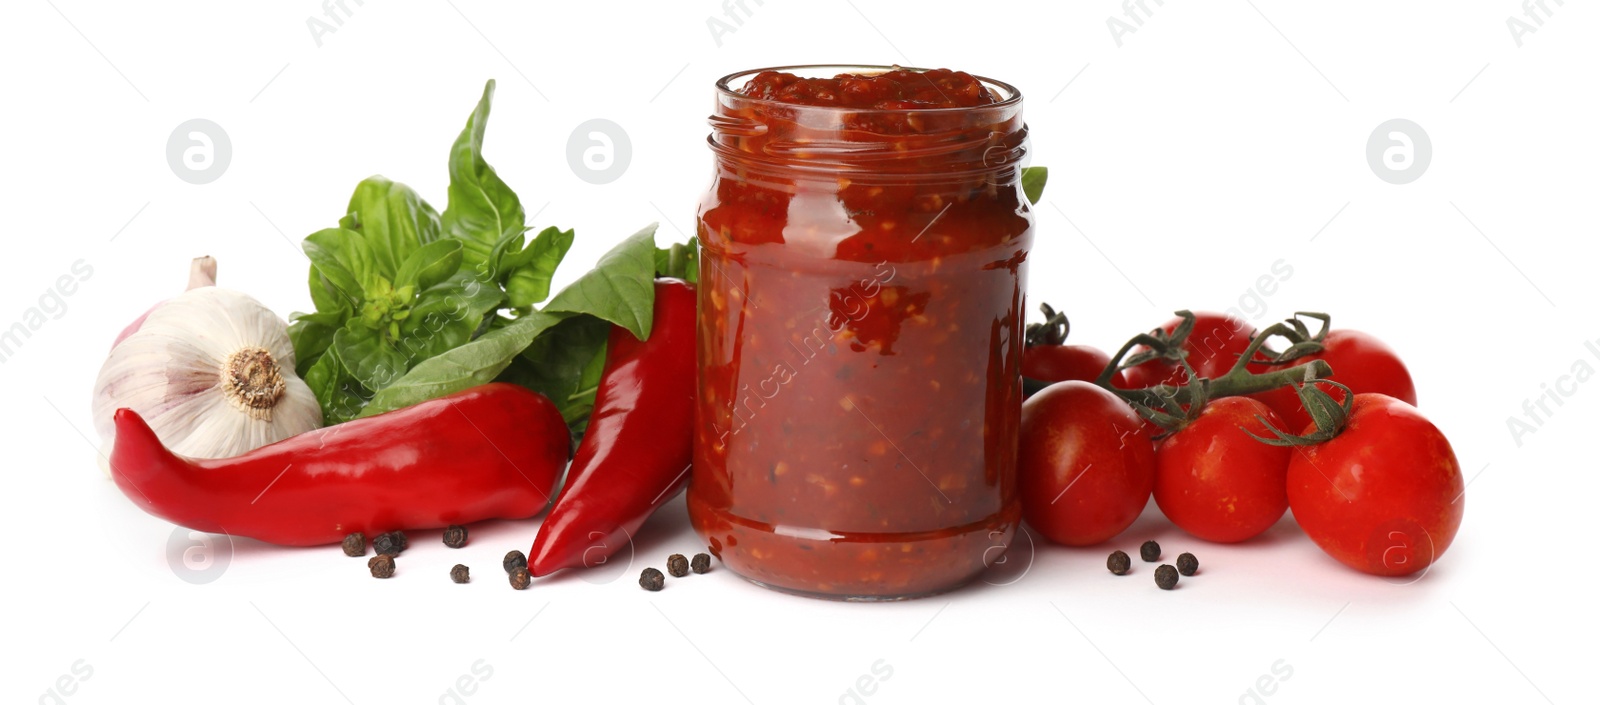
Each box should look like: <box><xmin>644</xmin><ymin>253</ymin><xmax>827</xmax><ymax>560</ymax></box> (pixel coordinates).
<box><xmin>110</xmin><ymin>384</ymin><xmax>571</xmax><ymax>545</ymax></box>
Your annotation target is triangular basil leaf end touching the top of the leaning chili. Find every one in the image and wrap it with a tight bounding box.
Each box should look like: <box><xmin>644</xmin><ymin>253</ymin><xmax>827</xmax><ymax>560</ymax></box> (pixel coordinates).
<box><xmin>544</xmin><ymin>224</ymin><xmax>656</xmax><ymax>341</ymax></box>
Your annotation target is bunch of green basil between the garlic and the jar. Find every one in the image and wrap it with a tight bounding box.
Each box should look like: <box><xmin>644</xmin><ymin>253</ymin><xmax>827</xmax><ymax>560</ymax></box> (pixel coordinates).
<box><xmin>290</xmin><ymin>80</ymin><xmax>672</xmax><ymax>422</ymax></box>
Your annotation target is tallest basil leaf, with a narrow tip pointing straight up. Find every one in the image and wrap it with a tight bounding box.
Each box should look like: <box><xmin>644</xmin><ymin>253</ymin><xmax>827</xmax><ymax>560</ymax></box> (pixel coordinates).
<box><xmin>440</xmin><ymin>80</ymin><xmax>523</xmax><ymax>272</ymax></box>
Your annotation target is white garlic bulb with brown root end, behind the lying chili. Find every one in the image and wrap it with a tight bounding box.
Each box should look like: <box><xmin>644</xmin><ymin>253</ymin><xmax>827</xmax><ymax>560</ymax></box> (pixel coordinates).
<box><xmin>93</xmin><ymin>279</ymin><xmax>322</xmax><ymax>457</ymax></box>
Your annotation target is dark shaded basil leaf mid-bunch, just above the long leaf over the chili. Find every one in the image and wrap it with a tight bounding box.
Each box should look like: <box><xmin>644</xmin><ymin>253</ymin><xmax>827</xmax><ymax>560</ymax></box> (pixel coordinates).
<box><xmin>394</xmin><ymin>270</ymin><xmax>502</xmax><ymax>362</ymax></box>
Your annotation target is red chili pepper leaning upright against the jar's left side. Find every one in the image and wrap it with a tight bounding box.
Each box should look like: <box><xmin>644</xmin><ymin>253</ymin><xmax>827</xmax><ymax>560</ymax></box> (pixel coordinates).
<box><xmin>528</xmin><ymin>278</ymin><xmax>696</xmax><ymax>576</ymax></box>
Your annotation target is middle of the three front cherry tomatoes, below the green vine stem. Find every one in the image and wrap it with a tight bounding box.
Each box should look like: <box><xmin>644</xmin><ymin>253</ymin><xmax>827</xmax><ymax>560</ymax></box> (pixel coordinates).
<box><xmin>1155</xmin><ymin>396</ymin><xmax>1293</xmax><ymax>544</ymax></box>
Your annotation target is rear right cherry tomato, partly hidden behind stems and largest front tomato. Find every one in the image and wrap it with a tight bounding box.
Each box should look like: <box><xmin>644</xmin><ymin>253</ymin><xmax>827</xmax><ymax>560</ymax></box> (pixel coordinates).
<box><xmin>1251</xmin><ymin>329</ymin><xmax>1416</xmax><ymax>433</ymax></box>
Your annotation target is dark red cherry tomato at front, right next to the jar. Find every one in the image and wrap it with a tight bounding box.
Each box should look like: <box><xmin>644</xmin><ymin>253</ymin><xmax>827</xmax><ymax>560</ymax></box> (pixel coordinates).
<box><xmin>1018</xmin><ymin>380</ymin><xmax>1155</xmax><ymax>545</ymax></box>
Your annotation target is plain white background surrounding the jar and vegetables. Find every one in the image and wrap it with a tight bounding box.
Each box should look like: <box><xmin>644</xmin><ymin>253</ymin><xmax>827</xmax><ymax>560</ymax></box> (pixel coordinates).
<box><xmin>0</xmin><ymin>0</ymin><xmax>1600</xmax><ymax>705</ymax></box>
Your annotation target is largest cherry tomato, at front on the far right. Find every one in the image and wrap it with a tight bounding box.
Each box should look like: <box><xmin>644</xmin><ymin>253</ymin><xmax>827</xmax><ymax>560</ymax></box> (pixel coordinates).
<box><xmin>1288</xmin><ymin>393</ymin><xmax>1466</xmax><ymax>576</ymax></box>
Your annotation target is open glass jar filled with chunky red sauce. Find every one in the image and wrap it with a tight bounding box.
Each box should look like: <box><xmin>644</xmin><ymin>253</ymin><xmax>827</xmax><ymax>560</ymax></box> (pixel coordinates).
<box><xmin>688</xmin><ymin>66</ymin><xmax>1034</xmax><ymax>599</ymax></box>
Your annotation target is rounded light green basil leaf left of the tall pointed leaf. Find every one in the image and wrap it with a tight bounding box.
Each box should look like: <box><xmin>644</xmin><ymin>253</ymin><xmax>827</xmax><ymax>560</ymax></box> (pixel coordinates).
<box><xmin>339</xmin><ymin>176</ymin><xmax>440</xmax><ymax>278</ymax></box>
